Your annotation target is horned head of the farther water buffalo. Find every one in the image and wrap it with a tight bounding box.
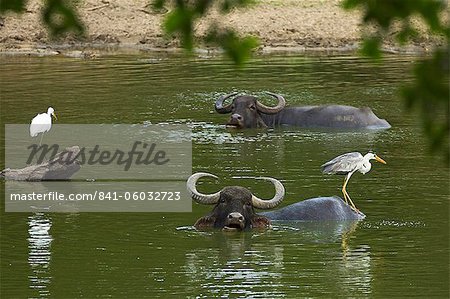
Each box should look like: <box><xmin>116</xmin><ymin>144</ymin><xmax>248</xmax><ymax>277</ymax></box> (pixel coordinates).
<box><xmin>215</xmin><ymin>92</ymin><xmax>286</xmax><ymax>129</ymax></box>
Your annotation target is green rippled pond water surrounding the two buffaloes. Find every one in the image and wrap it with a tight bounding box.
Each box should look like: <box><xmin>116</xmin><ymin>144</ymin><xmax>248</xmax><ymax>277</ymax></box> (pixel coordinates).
<box><xmin>0</xmin><ymin>54</ymin><xmax>449</xmax><ymax>298</ymax></box>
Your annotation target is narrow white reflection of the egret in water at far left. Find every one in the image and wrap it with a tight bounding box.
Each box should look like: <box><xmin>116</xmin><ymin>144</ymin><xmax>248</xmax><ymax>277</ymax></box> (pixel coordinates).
<box><xmin>28</xmin><ymin>213</ymin><xmax>53</xmax><ymax>297</ymax></box>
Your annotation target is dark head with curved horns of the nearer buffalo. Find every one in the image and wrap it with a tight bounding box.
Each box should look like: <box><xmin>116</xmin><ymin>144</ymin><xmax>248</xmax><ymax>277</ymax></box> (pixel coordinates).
<box><xmin>187</xmin><ymin>172</ymin><xmax>284</xmax><ymax>231</ymax></box>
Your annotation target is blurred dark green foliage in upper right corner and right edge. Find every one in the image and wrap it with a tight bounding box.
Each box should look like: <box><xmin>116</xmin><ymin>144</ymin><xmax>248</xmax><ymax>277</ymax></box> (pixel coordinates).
<box><xmin>343</xmin><ymin>0</ymin><xmax>450</xmax><ymax>165</ymax></box>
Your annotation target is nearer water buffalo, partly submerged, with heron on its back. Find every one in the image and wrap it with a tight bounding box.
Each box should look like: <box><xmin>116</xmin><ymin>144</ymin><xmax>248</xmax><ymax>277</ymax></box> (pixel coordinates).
<box><xmin>187</xmin><ymin>172</ymin><xmax>365</xmax><ymax>231</ymax></box>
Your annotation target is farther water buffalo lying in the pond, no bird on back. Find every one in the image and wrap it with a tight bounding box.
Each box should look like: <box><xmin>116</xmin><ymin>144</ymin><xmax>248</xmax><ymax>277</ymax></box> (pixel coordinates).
<box><xmin>215</xmin><ymin>92</ymin><xmax>391</xmax><ymax>129</ymax></box>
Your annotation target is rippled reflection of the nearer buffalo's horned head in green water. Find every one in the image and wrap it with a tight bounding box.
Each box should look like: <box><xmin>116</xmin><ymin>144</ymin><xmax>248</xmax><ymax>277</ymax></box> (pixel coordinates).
<box><xmin>185</xmin><ymin>236</ymin><xmax>283</xmax><ymax>298</ymax></box>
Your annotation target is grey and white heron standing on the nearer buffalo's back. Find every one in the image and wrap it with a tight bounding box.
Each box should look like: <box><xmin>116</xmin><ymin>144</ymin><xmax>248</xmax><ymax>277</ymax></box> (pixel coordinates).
<box><xmin>321</xmin><ymin>152</ymin><xmax>386</xmax><ymax>211</ymax></box>
